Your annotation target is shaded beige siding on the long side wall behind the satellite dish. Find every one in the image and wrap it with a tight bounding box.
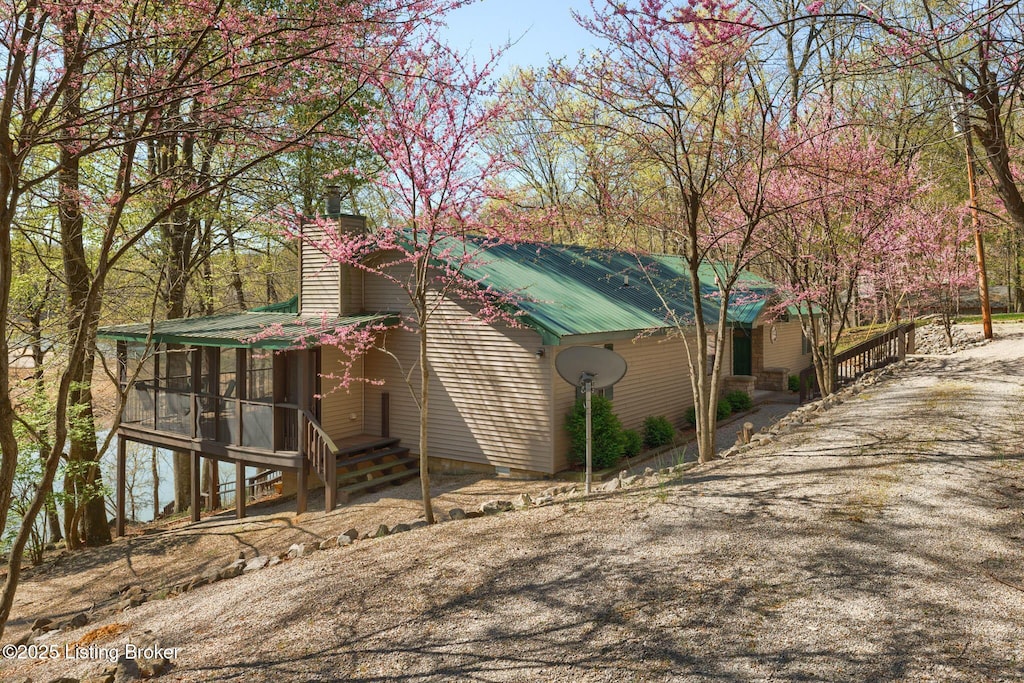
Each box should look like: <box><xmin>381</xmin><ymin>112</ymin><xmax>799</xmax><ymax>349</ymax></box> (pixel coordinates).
<box><xmin>552</xmin><ymin>337</ymin><xmax>693</xmax><ymax>469</ymax></box>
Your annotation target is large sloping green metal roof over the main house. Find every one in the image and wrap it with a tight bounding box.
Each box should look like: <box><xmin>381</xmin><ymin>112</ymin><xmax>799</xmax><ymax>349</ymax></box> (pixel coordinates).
<box><xmin>452</xmin><ymin>243</ymin><xmax>718</xmax><ymax>345</ymax></box>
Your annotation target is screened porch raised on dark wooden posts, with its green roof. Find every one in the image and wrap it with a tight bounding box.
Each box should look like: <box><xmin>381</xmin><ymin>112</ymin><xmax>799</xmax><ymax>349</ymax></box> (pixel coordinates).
<box><xmin>99</xmin><ymin>310</ymin><xmax>393</xmax><ymax>536</ymax></box>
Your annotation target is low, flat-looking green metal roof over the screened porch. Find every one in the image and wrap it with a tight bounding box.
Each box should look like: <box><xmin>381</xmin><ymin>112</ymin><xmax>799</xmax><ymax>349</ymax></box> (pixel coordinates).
<box><xmin>98</xmin><ymin>311</ymin><xmax>398</xmax><ymax>349</ymax></box>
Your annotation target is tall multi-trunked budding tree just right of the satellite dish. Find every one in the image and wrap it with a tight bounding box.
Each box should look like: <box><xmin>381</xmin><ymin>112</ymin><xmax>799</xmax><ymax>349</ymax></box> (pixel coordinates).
<box><xmin>556</xmin><ymin>0</ymin><xmax>778</xmax><ymax>462</ymax></box>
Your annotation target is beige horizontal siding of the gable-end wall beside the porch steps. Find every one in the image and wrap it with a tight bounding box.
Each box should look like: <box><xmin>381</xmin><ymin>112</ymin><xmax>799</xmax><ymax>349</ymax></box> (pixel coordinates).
<box><xmin>364</xmin><ymin>274</ymin><xmax>554</xmax><ymax>472</ymax></box>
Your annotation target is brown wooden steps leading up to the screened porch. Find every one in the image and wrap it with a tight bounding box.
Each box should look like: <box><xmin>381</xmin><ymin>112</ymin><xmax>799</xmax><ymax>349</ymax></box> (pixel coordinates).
<box><xmin>337</xmin><ymin>438</ymin><xmax>420</xmax><ymax>503</ymax></box>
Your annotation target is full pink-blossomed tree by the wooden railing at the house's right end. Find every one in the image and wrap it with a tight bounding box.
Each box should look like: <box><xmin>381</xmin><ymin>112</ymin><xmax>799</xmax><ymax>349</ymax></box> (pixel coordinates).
<box><xmin>759</xmin><ymin>112</ymin><xmax>919</xmax><ymax>394</ymax></box>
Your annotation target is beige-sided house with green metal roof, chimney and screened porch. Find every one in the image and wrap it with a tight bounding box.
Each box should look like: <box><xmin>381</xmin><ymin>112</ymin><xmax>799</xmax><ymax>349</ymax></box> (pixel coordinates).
<box><xmin>100</xmin><ymin>210</ymin><xmax>800</xmax><ymax>533</ymax></box>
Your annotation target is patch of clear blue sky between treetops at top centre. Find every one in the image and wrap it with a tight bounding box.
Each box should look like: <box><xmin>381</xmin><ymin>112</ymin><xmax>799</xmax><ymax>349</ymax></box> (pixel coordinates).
<box><xmin>441</xmin><ymin>0</ymin><xmax>593</xmax><ymax>76</ymax></box>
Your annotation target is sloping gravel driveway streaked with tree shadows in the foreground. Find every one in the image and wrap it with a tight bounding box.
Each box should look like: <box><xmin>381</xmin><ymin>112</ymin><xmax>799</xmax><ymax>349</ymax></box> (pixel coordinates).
<box><xmin>0</xmin><ymin>326</ymin><xmax>1024</xmax><ymax>681</ymax></box>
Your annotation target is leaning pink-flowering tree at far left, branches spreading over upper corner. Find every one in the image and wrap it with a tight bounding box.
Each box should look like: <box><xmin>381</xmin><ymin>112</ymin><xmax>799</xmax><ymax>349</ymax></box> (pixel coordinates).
<box><xmin>0</xmin><ymin>0</ymin><xmax>458</xmax><ymax>635</ymax></box>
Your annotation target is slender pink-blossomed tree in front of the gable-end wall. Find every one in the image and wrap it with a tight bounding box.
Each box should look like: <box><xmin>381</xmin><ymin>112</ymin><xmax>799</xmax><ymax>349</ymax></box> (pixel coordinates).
<box><xmin>306</xmin><ymin>35</ymin><xmax>518</xmax><ymax>523</ymax></box>
